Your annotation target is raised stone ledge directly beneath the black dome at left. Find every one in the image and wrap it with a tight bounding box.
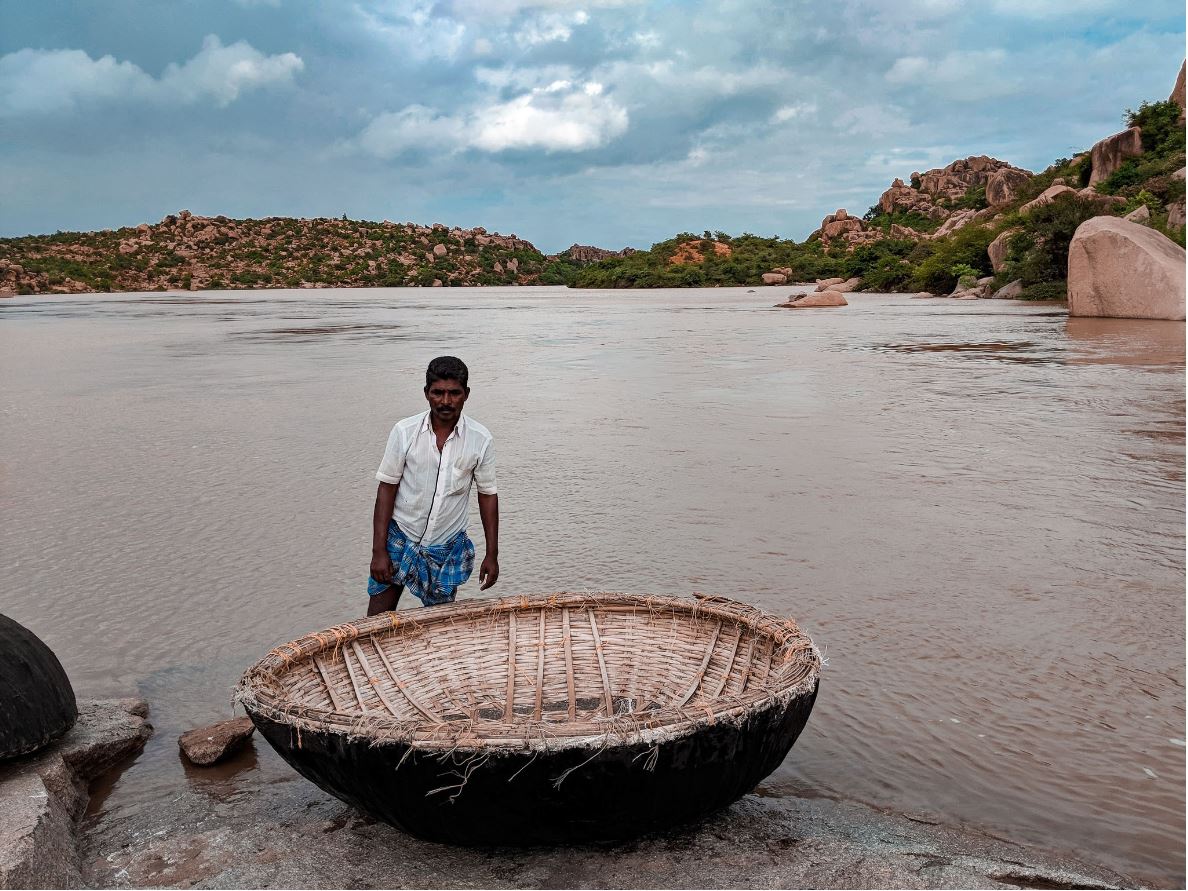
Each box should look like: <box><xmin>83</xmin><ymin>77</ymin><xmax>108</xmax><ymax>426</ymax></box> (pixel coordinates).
<box><xmin>0</xmin><ymin>699</ymin><xmax>152</xmax><ymax>889</ymax></box>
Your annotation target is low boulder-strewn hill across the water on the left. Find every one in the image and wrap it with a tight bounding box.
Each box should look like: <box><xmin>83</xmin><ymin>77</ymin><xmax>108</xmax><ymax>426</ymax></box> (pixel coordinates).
<box><xmin>0</xmin><ymin>210</ymin><xmax>570</xmax><ymax>295</ymax></box>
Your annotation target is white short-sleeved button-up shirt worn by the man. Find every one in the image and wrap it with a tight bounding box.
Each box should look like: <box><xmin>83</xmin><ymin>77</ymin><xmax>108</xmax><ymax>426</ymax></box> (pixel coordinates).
<box><xmin>375</xmin><ymin>411</ymin><xmax>495</xmax><ymax>546</ymax></box>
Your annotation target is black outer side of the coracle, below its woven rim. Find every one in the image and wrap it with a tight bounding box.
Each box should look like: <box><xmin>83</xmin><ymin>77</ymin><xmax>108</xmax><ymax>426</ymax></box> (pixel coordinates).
<box><xmin>252</xmin><ymin>689</ymin><xmax>816</xmax><ymax>845</ymax></box>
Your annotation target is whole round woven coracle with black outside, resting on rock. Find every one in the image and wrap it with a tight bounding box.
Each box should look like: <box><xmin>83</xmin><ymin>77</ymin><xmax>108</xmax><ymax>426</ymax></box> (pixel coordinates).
<box><xmin>236</xmin><ymin>593</ymin><xmax>821</xmax><ymax>845</ymax></box>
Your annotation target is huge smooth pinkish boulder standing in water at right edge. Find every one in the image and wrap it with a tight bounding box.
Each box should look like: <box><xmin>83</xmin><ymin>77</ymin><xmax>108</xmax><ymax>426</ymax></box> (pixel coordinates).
<box><xmin>1068</xmin><ymin>216</ymin><xmax>1184</xmax><ymax>321</ymax></box>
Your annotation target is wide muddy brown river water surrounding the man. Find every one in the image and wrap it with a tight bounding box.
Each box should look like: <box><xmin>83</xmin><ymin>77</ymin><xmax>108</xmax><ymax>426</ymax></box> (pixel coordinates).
<box><xmin>0</xmin><ymin>289</ymin><xmax>1184</xmax><ymax>886</ymax></box>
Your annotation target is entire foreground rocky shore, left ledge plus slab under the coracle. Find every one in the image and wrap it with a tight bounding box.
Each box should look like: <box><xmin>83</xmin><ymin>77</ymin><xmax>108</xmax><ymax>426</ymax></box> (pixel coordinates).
<box><xmin>0</xmin><ymin>700</ymin><xmax>1137</xmax><ymax>889</ymax></box>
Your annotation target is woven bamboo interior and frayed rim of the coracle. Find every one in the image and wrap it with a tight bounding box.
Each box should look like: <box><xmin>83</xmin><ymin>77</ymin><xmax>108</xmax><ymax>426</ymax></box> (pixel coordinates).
<box><xmin>238</xmin><ymin>593</ymin><xmax>821</xmax><ymax>747</ymax></box>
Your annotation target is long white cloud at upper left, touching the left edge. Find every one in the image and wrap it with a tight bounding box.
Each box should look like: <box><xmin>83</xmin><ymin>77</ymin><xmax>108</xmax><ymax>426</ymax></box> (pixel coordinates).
<box><xmin>0</xmin><ymin>34</ymin><xmax>304</xmax><ymax>116</ymax></box>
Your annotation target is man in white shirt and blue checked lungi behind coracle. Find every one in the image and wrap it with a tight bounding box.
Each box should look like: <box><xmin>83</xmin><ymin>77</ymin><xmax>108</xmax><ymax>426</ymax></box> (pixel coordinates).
<box><xmin>367</xmin><ymin>355</ymin><xmax>499</xmax><ymax>615</ymax></box>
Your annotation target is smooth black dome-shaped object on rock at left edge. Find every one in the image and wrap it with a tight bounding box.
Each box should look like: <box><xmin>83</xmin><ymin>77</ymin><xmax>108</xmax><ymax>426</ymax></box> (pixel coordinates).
<box><xmin>0</xmin><ymin>615</ymin><xmax>78</xmax><ymax>759</ymax></box>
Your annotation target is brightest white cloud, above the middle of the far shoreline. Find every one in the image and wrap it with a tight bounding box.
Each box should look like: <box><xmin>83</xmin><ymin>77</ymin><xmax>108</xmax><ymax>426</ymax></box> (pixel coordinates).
<box><xmin>358</xmin><ymin>80</ymin><xmax>628</xmax><ymax>158</ymax></box>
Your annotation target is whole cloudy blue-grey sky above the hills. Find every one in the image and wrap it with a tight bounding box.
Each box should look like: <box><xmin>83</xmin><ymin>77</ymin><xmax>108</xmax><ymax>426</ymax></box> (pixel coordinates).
<box><xmin>0</xmin><ymin>0</ymin><xmax>1184</xmax><ymax>251</ymax></box>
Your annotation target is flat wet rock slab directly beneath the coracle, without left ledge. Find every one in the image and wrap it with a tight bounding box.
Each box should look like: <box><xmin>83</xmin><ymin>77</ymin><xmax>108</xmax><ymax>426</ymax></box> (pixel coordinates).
<box><xmin>83</xmin><ymin>751</ymin><xmax>1135</xmax><ymax>889</ymax></box>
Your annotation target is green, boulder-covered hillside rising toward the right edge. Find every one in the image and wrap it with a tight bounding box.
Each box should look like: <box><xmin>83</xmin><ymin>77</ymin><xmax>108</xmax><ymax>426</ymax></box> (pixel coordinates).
<box><xmin>573</xmin><ymin>67</ymin><xmax>1184</xmax><ymax>299</ymax></box>
